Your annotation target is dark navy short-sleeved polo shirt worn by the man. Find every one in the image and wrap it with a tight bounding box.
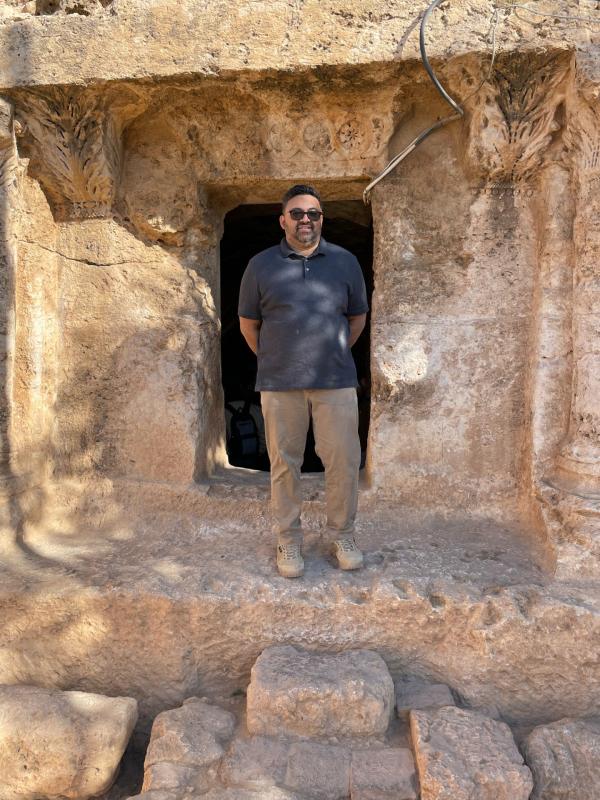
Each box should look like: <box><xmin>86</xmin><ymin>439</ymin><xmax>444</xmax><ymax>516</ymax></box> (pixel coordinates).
<box><xmin>238</xmin><ymin>238</ymin><xmax>369</xmax><ymax>391</ymax></box>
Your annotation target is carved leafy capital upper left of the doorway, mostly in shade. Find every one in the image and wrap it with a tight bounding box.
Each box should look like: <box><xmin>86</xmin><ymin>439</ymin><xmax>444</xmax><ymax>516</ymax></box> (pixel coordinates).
<box><xmin>19</xmin><ymin>88</ymin><xmax>121</xmax><ymax>221</ymax></box>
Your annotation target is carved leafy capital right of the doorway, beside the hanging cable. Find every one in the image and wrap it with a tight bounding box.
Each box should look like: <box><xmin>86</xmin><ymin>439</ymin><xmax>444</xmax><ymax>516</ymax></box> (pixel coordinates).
<box><xmin>460</xmin><ymin>56</ymin><xmax>569</xmax><ymax>184</ymax></box>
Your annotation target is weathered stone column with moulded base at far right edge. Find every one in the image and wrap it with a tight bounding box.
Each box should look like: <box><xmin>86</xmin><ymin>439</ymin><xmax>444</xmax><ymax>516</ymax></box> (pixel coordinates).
<box><xmin>548</xmin><ymin>55</ymin><xmax>600</xmax><ymax>577</ymax></box>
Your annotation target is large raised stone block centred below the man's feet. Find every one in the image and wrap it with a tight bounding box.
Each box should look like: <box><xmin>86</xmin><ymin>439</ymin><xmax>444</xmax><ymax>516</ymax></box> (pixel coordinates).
<box><xmin>247</xmin><ymin>645</ymin><xmax>394</xmax><ymax>737</ymax></box>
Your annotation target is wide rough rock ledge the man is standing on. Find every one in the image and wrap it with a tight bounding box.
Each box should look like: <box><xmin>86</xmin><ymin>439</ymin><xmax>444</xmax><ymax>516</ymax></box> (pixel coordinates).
<box><xmin>0</xmin><ymin>487</ymin><xmax>600</xmax><ymax>744</ymax></box>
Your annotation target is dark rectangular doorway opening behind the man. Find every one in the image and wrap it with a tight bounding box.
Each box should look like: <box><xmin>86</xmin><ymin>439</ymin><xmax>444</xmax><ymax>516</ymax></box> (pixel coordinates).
<box><xmin>221</xmin><ymin>200</ymin><xmax>373</xmax><ymax>472</ymax></box>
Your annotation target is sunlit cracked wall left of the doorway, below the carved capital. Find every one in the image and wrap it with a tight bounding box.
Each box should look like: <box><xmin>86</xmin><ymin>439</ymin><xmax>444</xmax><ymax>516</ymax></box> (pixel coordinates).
<box><xmin>12</xmin><ymin>175</ymin><xmax>223</xmax><ymax>483</ymax></box>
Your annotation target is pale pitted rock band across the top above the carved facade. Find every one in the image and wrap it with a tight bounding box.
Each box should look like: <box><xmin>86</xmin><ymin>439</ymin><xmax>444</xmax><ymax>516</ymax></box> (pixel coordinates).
<box><xmin>0</xmin><ymin>0</ymin><xmax>589</xmax><ymax>86</ymax></box>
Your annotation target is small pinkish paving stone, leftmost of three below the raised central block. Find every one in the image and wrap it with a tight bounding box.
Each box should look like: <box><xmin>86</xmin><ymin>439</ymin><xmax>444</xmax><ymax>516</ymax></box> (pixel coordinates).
<box><xmin>220</xmin><ymin>736</ymin><xmax>289</xmax><ymax>789</ymax></box>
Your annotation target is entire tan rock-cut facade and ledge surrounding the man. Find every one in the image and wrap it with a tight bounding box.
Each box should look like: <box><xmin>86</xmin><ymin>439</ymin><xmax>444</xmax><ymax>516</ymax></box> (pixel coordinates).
<box><xmin>0</xmin><ymin>0</ymin><xmax>600</xmax><ymax>792</ymax></box>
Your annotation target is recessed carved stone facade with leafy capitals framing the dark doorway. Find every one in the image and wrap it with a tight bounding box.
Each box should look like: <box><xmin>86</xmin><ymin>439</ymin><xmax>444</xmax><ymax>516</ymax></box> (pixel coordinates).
<box><xmin>3</xmin><ymin>53</ymin><xmax>600</xmax><ymax>569</ymax></box>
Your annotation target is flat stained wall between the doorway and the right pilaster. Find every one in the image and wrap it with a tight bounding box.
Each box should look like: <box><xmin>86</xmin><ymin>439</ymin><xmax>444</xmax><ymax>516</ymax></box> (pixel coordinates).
<box><xmin>370</xmin><ymin>108</ymin><xmax>536</xmax><ymax>509</ymax></box>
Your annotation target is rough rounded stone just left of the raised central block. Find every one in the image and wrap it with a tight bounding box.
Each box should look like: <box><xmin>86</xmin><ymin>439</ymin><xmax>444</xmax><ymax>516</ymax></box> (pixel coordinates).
<box><xmin>142</xmin><ymin>698</ymin><xmax>235</xmax><ymax>791</ymax></box>
